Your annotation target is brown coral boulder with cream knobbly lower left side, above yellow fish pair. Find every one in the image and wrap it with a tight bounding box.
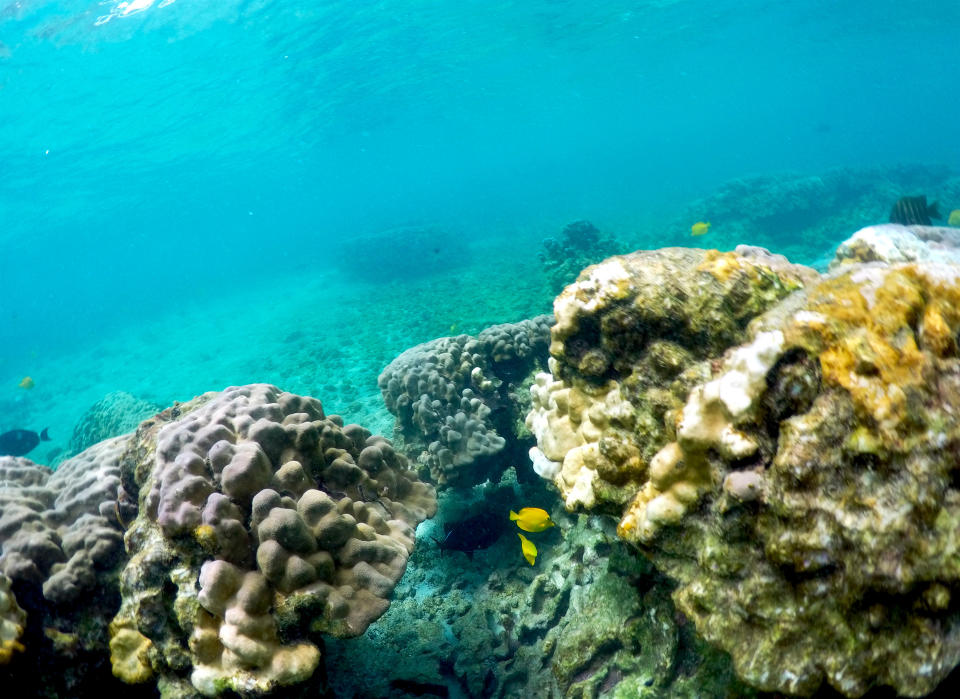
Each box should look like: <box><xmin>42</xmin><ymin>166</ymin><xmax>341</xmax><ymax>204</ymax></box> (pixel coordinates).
<box><xmin>527</xmin><ymin>248</ymin><xmax>818</xmax><ymax>512</ymax></box>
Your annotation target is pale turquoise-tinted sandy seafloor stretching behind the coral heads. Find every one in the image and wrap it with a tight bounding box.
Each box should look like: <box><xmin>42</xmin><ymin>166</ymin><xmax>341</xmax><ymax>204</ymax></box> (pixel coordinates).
<box><xmin>0</xmin><ymin>239</ymin><xmax>552</xmax><ymax>464</ymax></box>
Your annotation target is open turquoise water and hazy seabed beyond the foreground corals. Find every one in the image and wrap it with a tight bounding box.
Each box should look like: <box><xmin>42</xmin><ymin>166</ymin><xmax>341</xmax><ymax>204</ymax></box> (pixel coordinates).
<box><xmin>0</xmin><ymin>0</ymin><xmax>960</xmax><ymax>461</ymax></box>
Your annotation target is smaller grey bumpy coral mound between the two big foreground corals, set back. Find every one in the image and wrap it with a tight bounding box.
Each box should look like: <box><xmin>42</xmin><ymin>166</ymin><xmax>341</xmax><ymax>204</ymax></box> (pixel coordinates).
<box><xmin>378</xmin><ymin>315</ymin><xmax>553</xmax><ymax>485</ymax></box>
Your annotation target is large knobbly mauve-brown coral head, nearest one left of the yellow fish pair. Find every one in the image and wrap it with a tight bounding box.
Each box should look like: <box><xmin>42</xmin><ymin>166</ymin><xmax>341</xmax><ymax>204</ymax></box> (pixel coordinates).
<box><xmin>110</xmin><ymin>384</ymin><xmax>436</xmax><ymax>696</ymax></box>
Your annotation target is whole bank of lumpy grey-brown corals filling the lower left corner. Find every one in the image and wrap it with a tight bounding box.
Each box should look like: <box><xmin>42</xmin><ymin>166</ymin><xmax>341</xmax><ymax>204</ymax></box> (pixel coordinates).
<box><xmin>0</xmin><ymin>384</ymin><xmax>436</xmax><ymax>697</ymax></box>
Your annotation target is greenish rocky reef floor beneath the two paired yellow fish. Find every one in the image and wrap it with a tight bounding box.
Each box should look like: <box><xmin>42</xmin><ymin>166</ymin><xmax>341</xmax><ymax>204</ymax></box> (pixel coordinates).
<box><xmin>327</xmin><ymin>469</ymin><xmax>753</xmax><ymax>699</ymax></box>
